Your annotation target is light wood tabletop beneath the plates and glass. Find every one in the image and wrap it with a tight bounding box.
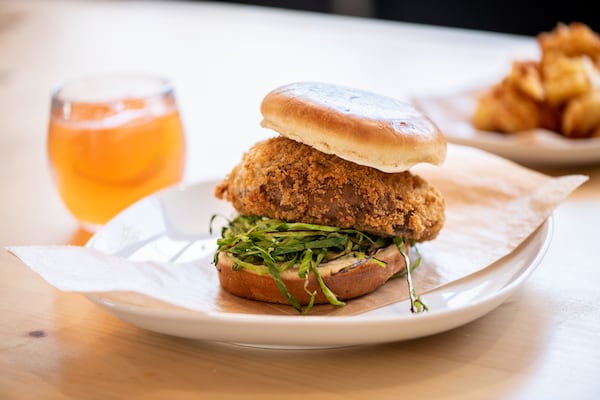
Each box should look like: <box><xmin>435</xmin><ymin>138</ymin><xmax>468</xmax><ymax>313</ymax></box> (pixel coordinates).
<box><xmin>0</xmin><ymin>1</ymin><xmax>600</xmax><ymax>400</ymax></box>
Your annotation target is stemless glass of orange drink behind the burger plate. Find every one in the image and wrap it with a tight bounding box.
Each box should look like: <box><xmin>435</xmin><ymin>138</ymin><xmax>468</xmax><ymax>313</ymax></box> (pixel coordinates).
<box><xmin>47</xmin><ymin>74</ymin><xmax>185</xmax><ymax>231</ymax></box>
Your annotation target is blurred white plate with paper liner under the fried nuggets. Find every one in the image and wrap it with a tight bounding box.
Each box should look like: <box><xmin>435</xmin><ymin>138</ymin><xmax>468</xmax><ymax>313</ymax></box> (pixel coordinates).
<box><xmin>413</xmin><ymin>91</ymin><xmax>600</xmax><ymax>166</ymax></box>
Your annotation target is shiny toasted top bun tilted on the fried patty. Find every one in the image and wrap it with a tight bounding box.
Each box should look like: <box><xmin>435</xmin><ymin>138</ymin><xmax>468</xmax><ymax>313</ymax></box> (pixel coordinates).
<box><xmin>261</xmin><ymin>82</ymin><xmax>446</xmax><ymax>172</ymax></box>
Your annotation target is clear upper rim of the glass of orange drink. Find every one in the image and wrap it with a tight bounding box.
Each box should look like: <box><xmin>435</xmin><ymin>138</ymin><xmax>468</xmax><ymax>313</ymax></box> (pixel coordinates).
<box><xmin>51</xmin><ymin>72</ymin><xmax>174</xmax><ymax>104</ymax></box>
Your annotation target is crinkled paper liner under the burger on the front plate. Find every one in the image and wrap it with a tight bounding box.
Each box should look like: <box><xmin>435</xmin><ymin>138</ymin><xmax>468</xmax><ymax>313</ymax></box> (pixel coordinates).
<box><xmin>7</xmin><ymin>145</ymin><xmax>588</xmax><ymax>315</ymax></box>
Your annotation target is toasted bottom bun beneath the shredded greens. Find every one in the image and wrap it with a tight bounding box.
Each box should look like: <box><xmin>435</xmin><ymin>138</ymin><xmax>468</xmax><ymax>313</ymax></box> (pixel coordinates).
<box><xmin>217</xmin><ymin>244</ymin><xmax>409</xmax><ymax>305</ymax></box>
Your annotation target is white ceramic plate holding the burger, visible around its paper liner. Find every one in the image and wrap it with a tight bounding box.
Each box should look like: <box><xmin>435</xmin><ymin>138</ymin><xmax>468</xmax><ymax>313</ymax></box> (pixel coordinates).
<box><xmin>87</xmin><ymin>183</ymin><xmax>552</xmax><ymax>348</ymax></box>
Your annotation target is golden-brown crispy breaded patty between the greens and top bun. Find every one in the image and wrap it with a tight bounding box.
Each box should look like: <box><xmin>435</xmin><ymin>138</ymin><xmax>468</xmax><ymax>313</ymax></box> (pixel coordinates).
<box><xmin>215</xmin><ymin>137</ymin><xmax>445</xmax><ymax>242</ymax></box>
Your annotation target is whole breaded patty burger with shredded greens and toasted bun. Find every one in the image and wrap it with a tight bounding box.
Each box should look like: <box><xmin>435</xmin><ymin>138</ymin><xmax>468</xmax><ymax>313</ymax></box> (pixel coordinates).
<box><xmin>214</xmin><ymin>82</ymin><xmax>446</xmax><ymax>312</ymax></box>
